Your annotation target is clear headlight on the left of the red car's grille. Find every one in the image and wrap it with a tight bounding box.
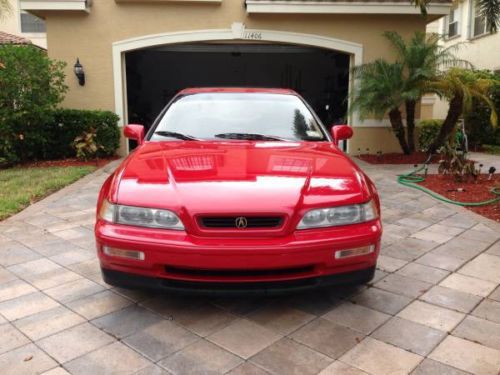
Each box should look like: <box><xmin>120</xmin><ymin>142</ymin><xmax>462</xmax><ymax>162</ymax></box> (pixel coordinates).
<box><xmin>99</xmin><ymin>201</ymin><xmax>184</xmax><ymax>230</ymax></box>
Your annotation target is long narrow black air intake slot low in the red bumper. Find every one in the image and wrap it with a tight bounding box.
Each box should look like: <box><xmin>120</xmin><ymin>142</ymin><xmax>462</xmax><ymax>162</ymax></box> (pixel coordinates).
<box><xmin>165</xmin><ymin>266</ymin><xmax>314</xmax><ymax>277</ymax></box>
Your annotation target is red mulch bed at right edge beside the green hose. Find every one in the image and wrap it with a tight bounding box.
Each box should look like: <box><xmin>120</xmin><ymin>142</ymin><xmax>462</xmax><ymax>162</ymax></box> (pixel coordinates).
<box><xmin>420</xmin><ymin>174</ymin><xmax>500</xmax><ymax>222</ymax></box>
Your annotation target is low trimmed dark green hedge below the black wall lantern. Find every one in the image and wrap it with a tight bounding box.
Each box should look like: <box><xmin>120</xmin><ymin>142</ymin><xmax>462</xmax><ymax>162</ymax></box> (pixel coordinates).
<box><xmin>16</xmin><ymin>109</ymin><xmax>120</xmax><ymax>160</ymax></box>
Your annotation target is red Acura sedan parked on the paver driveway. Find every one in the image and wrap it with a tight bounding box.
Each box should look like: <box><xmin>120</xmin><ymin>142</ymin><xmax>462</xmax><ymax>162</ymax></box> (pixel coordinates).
<box><xmin>95</xmin><ymin>88</ymin><xmax>382</xmax><ymax>293</ymax></box>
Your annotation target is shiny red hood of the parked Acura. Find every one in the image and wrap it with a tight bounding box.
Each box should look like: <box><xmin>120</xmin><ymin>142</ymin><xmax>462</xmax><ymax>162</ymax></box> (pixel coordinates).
<box><xmin>111</xmin><ymin>141</ymin><xmax>370</xmax><ymax>217</ymax></box>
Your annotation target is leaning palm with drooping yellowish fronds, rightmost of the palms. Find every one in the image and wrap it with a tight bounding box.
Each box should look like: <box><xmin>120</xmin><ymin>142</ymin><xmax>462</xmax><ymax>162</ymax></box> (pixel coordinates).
<box><xmin>427</xmin><ymin>68</ymin><xmax>497</xmax><ymax>154</ymax></box>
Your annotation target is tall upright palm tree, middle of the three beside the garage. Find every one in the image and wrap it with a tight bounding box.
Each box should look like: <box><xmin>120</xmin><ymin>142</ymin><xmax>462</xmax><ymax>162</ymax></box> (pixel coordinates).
<box><xmin>384</xmin><ymin>31</ymin><xmax>471</xmax><ymax>153</ymax></box>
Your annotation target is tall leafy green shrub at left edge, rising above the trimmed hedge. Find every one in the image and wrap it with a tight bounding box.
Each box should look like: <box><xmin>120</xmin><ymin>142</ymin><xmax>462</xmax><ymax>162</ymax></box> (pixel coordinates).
<box><xmin>0</xmin><ymin>45</ymin><xmax>67</xmax><ymax>163</ymax></box>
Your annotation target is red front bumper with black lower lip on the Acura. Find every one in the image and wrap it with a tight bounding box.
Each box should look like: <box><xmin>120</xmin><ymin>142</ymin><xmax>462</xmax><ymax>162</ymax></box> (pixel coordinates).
<box><xmin>95</xmin><ymin>220</ymin><xmax>382</xmax><ymax>292</ymax></box>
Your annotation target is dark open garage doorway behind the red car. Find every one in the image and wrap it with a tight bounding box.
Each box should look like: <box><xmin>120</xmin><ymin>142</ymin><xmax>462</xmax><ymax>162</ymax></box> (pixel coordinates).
<box><xmin>125</xmin><ymin>43</ymin><xmax>350</xmax><ymax>142</ymax></box>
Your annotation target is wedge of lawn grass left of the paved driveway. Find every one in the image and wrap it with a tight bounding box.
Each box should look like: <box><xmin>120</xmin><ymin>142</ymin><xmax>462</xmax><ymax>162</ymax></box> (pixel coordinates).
<box><xmin>0</xmin><ymin>166</ymin><xmax>96</xmax><ymax>220</ymax></box>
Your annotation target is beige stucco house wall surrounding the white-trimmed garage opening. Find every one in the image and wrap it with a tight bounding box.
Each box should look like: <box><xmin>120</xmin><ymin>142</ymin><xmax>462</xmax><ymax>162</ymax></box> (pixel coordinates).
<box><xmin>42</xmin><ymin>0</ymin><xmax>425</xmax><ymax>155</ymax></box>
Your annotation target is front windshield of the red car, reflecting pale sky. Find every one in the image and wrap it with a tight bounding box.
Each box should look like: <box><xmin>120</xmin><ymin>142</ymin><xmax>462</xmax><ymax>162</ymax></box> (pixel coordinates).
<box><xmin>149</xmin><ymin>93</ymin><xmax>328</xmax><ymax>141</ymax></box>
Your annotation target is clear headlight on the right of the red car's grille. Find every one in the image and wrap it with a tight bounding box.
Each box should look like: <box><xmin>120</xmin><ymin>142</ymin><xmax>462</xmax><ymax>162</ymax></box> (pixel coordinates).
<box><xmin>297</xmin><ymin>201</ymin><xmax>378</xmax><ymax>229</ymax></box>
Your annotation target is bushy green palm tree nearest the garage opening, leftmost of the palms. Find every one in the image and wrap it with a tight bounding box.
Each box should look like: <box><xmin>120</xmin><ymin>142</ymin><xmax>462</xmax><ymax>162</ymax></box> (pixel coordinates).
<box><xmin>350</xmin><ymin>59</ymin><xmax>410</xmax><ymax>154</ymax></box>
